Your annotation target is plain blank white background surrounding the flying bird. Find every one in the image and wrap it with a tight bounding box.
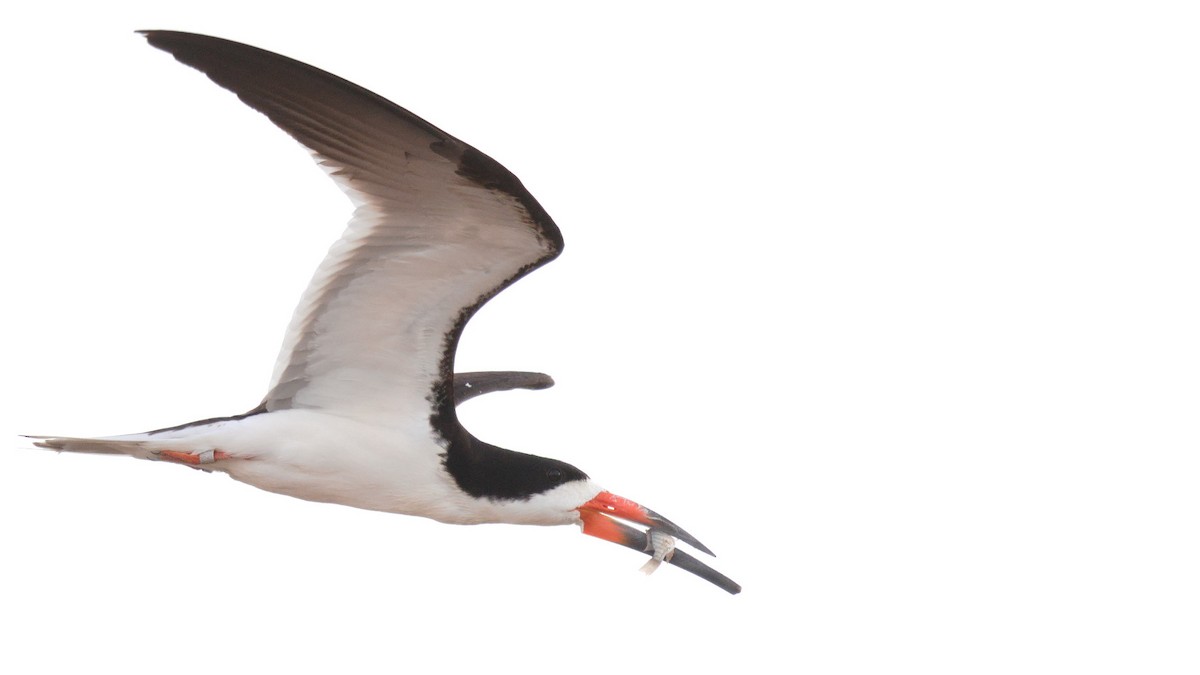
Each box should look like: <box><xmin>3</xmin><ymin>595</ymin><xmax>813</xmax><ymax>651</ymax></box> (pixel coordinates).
<box><xmin>0</xmin><ymin>1</ymin><xmax>1200</xmax><ymax>674</ymax></box>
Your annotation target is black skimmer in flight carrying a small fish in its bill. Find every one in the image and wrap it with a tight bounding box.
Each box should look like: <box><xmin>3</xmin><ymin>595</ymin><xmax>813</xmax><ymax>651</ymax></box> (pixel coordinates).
<box><xmin>35</xmin><ymin>30</ymin><xmax>740</xmax><ymax>593</ymax></box>
